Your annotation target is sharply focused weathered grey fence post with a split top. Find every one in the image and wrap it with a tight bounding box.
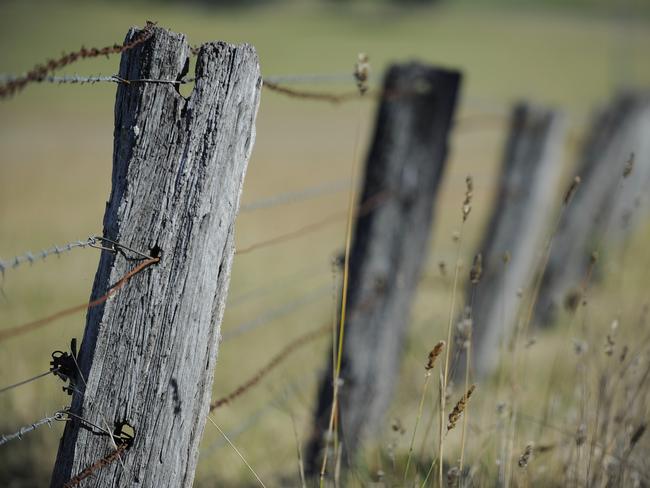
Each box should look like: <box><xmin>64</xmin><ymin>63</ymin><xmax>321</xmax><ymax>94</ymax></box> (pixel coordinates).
<box><xmin>51</xmin><ymin>28</ymin><xmax>261</xmax><ymax>487</ymax></box>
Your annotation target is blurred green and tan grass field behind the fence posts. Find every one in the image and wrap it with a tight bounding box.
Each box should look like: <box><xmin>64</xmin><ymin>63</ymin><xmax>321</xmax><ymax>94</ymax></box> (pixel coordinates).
<box><xmin>0</xmin><ymin>0</ymin><xmax>650</xmax><ymax>487</ymax></box>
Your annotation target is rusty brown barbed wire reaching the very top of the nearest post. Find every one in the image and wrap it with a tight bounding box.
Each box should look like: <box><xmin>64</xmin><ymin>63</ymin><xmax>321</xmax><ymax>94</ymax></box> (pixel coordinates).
<box><xmin>0</xmin><ymin>21</ymin><xmax>155</xmax><ymax>98</ymax></box>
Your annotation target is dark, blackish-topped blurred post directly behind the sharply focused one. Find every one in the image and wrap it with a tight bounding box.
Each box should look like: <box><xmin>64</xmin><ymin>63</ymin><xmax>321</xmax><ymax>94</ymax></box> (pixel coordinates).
<box><xmin>307</xmin><ymin>63</ymin><xmax>461</xmax><ymax>474</ymax></box>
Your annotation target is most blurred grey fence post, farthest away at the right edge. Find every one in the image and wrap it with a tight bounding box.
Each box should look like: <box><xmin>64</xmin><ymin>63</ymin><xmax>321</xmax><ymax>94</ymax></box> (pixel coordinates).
<box><xmin>535</xmin><ymin>93</ymin><xmax>650</xmax><ymax>324</ymax></box>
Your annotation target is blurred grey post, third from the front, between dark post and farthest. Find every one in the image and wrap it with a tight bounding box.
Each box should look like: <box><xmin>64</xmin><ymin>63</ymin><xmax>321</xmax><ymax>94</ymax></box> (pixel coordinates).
<box><xmin>456</xmin><ymin>103</ymin><xmax>565</xmax><ymax>375</ymax></box>
